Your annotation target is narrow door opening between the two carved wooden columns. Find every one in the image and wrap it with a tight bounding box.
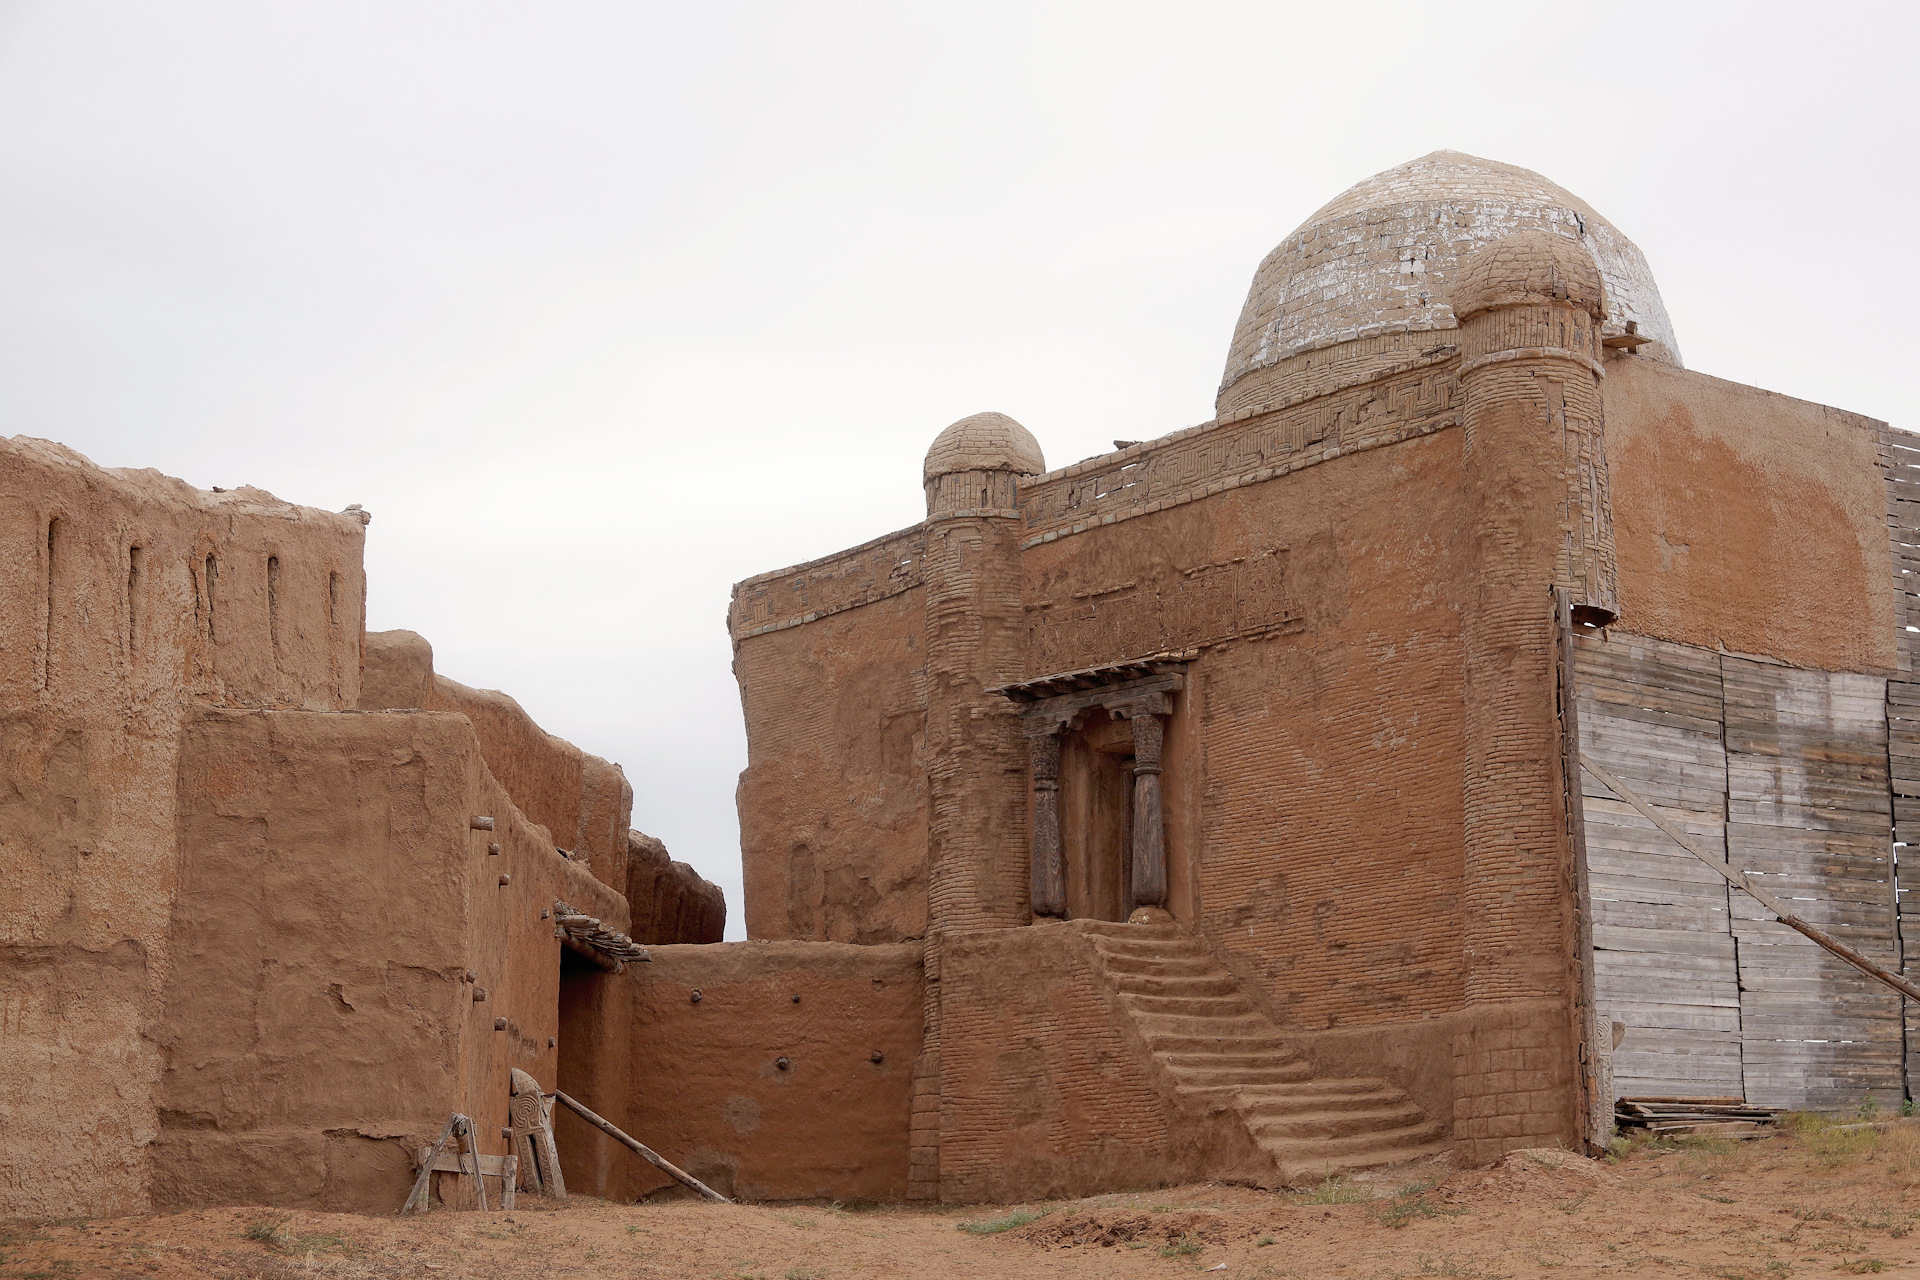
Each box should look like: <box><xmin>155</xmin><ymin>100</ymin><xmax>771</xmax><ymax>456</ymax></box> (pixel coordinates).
<box><xmin>1060</xmin><ymin>710</ymin><xmax>1133</xmax><ymax>921</ymax></box>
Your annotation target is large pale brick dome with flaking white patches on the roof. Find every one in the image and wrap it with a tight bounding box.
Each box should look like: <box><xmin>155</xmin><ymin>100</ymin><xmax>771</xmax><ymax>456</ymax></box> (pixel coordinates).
<box><xmin>1219</xmin><ymin>152</ymin><xmax>1680</xmax><ymax>415</ymax></box>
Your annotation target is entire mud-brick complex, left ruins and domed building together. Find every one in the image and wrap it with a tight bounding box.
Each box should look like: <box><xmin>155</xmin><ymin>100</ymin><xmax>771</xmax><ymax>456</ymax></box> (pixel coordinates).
<box><xmin>0</xmin><ymin>152</ymin><xmax>1920</xmax><ymax>1215</ymax></box>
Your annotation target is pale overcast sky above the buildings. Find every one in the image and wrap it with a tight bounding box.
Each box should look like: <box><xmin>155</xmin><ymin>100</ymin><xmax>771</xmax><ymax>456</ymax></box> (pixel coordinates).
<box><xmin>0</xmin><ymin>0</ymin><xmax>1920</xmax><ymax>936</ymax></box>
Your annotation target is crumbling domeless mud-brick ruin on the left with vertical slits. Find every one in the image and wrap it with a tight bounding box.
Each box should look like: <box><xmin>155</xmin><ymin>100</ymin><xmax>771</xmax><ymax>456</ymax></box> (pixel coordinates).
<box><xmin>0</xmin><ymin>438</ymin><xmax>691</xmax><ymax>1215</ymax></box>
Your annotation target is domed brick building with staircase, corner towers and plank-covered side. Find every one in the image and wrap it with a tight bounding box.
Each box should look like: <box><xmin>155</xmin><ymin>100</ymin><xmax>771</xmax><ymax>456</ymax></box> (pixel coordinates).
<box><xmin>698</xmin><ymin>152</ymin><xmax>1914</xmax><ymax>1199</ymax></box>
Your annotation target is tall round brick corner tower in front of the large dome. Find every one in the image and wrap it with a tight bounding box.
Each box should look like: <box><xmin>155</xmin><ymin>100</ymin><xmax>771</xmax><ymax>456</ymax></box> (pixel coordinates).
<box><xmin>1452</xmin><ymin>230</ymin><xmax>1619</xmax><ymax>1163</ymax></box>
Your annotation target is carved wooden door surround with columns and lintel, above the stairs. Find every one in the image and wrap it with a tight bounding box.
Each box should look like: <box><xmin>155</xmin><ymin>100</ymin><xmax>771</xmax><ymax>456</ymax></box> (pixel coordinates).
<box><xmin>993</xmin><ymin>658</ymin><xmax>1187</xmax><ymax>921</ymax></box>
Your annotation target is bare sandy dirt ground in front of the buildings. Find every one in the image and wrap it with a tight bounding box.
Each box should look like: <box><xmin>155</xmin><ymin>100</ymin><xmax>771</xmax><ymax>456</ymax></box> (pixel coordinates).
<box><xmin>11</xmin><ymin>1121</ymin><xmax>1920</xmax><ymax>1280</ymax></box>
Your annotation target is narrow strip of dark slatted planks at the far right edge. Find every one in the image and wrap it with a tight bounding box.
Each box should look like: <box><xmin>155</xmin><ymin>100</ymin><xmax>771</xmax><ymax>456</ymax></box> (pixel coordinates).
<box><xmin>1880</xmin><ymin>428</ymin><xmax>1920</xmax><ymax>1098</ymax></box>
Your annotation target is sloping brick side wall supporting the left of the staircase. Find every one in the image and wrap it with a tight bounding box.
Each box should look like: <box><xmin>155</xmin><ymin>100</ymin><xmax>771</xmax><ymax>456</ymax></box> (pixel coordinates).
<box><xmin>939</xmin><ymin>921</ymin><xmax>1254</xmax><ymax>1203</ymax></box>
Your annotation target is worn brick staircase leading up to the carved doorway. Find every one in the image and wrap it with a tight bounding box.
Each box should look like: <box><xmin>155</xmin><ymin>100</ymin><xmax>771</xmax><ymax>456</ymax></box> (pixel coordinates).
<box><xmin>1075</xmin><ymin>921</ymin><xmax>1452</xmax><ymax>1186</ymax></box>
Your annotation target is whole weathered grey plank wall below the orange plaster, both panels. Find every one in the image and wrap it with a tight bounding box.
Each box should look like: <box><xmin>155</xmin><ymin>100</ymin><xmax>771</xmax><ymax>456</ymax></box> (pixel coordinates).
<box><xmin>1576</xmin><ymin>637</ymin><xmax>1920</xmax><ymax>1109</ymax></box>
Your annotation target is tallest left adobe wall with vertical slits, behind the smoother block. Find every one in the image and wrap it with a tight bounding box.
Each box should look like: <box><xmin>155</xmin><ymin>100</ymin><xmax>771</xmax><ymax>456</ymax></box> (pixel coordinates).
<box><xmin>0</xmin><ymin>438</ymin><xmax>365</xmax><ymax>1215</ymax></box>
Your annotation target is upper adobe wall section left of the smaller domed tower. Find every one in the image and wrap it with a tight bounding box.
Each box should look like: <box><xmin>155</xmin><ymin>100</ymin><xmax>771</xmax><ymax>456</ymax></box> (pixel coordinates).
<box><xmin>728</xmin><ymin>528</ymin><xmax>927</xmax><ymax>942</ymax></box>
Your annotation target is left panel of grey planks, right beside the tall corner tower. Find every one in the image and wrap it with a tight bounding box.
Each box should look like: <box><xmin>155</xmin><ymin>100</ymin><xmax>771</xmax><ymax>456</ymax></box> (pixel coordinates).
<box><xmin>1574</xmin><ymin>637</ymin><xmax>1741</xmax><ymax>1096</ymax></box>
